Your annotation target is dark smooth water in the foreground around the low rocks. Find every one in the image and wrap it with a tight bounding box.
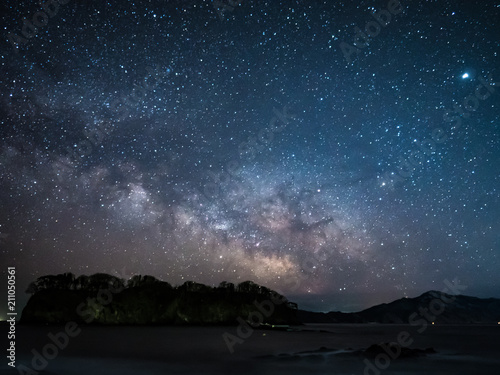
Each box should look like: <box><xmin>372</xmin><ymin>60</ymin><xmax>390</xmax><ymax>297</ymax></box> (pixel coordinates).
<box><xmin>0</xmin><ymin>324</ymin><xmax>500</xmax><ymax>375</ymax></box>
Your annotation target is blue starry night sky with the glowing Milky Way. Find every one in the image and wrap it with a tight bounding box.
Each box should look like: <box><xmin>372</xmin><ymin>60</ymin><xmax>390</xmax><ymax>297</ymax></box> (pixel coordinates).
<box><xmin>0</xmin><ymin>0</ymin><xmax>500</xmax><ymax>311</ymax></box>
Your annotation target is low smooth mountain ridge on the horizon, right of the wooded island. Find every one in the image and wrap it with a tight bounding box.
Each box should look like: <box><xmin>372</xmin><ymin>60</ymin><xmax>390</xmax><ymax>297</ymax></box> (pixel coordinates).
<box><xmin>297</xmin><ymin>291</ymin><xmax>500</xmax><ymax>325</ymax></box>
